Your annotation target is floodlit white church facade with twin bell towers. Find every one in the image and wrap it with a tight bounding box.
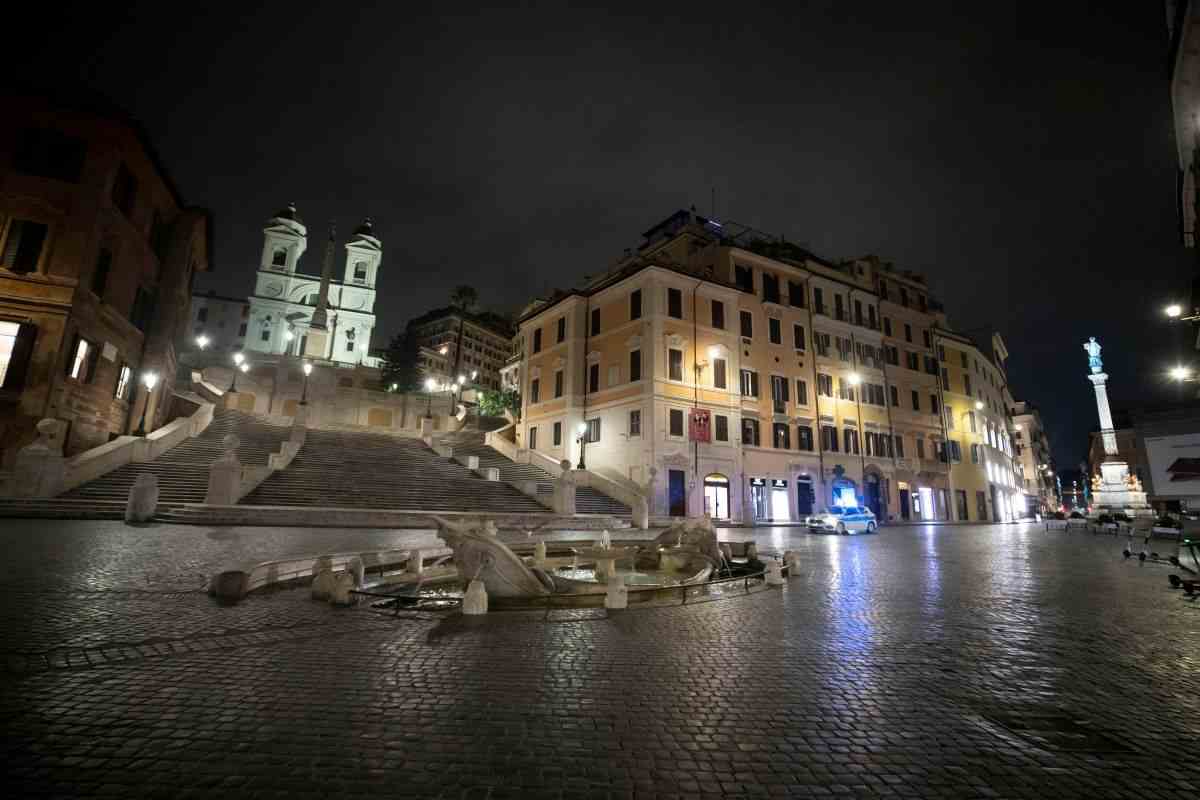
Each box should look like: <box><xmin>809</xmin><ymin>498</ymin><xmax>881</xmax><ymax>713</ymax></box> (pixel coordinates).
<box><xmin>245</xmin><ymin>205</ymin><xmax>383</xmax><ymax>367</ymax></box>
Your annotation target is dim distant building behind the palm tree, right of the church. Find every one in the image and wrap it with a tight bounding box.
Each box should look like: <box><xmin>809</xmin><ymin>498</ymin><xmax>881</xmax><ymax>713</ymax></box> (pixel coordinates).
<box><xmin>408</xmin><ymin>307</ymin><xmax>512</xmax><ymax>389</ymax></box>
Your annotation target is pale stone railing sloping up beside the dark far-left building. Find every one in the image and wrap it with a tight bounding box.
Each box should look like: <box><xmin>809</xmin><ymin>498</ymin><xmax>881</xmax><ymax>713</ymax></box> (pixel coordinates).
<box><xmin>5</xmin><ymin>395</ymin><xmax>214</xmax><ymax>497</ymax></box>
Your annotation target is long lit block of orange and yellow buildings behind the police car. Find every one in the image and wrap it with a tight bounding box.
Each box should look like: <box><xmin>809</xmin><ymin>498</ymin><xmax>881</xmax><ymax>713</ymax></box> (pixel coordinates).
<box><xmin>515</xmin><ymin>211</ymin><xmax>1020</xmax><ymax>522</ymax></box>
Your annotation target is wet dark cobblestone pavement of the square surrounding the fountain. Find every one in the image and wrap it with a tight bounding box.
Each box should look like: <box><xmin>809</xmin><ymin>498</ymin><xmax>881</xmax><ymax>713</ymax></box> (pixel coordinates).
<box><xmin>0</xmin><ymin>522</ymin><xmax>1200</xmax><ymax>799</ymax></box>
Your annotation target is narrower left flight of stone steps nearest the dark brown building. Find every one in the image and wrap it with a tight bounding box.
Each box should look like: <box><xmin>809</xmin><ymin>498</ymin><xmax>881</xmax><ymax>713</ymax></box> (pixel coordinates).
<box><xmin>54</xmin><ymin>408</ymin><xmax>290</xmax><ymax>511</ymax></box>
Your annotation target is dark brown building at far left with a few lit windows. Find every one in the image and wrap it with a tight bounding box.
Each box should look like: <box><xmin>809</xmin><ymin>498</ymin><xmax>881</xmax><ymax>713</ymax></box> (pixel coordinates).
<box><xmin>0</xmin><ymin>90</ymin><xmax>210</xmax><ymax>463</ymax></box>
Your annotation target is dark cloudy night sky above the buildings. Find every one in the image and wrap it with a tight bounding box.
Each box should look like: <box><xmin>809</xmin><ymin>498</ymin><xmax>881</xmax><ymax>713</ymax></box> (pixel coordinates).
<box><xmin>21</xmin><ymin>0</ymin><xmax>1193</xmax><ymax>468</ymax></box>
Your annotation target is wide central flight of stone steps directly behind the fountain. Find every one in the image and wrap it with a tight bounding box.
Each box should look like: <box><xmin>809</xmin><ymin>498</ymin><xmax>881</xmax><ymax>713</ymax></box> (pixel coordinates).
<box><xmin>242</xmin><ymin>429</ymin><xmax>548</xmax><ymax>513</ymax></box>
